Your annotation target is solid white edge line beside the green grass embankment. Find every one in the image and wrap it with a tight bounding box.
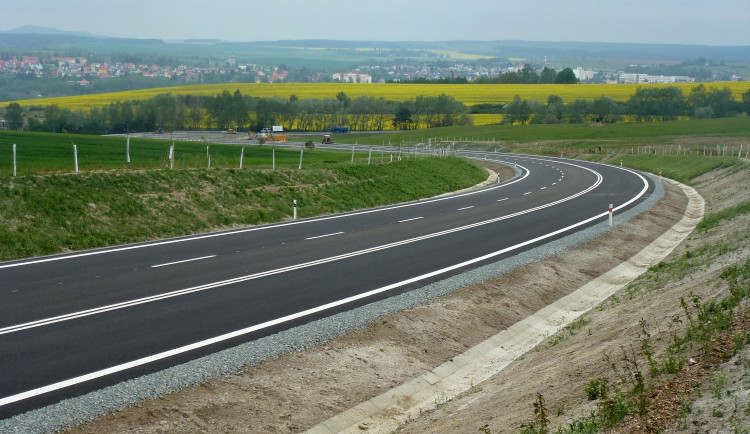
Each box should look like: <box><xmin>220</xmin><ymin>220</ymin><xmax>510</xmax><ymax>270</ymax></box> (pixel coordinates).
<box><xmin>0</xmin><ymin>164</ymin><xmax>531</xmax><ymax>269</ymax></box>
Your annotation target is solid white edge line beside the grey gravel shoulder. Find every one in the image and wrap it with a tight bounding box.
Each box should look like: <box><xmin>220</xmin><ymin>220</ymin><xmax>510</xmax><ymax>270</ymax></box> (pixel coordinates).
<box><xmin>0</xmin><ymin>164</ymin><xmax>648</xmax><ymax>407</ymax></box>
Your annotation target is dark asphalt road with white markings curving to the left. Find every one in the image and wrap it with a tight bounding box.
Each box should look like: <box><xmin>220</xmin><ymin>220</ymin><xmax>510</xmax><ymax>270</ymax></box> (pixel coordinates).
<box><xmin>0</xmin><ymin>153</ymin><xmax>653</xmax><ymax>418</ymax></box>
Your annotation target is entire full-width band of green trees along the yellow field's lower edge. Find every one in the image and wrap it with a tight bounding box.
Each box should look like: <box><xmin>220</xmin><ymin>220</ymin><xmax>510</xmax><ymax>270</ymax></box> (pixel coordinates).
<box><xmin>5</xmin><ymin>85</ymin><xmax>750</xmax><ymax>134</ymax></box>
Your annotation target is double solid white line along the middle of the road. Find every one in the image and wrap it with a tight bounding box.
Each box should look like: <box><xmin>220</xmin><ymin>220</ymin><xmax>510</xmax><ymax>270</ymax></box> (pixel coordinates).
<box><xmin>0</xmin><ymin>166</ymin><xmax>604</xmax><ymax>335</ymax></box>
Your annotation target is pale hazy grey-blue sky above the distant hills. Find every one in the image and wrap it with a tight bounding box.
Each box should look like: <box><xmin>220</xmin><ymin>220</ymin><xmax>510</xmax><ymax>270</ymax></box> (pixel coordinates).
<box><xmin>0</xmin><ymin>0</ymin><xmax>750</xmax><ymax>45</ymax></box>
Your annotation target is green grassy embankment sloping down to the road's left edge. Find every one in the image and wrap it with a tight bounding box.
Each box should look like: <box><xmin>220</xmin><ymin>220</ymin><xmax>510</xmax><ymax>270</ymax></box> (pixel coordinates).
<box><xmin>0</xmin><ymin>158</ymin><xmax>486</xmax><ymax>260</ymax></box>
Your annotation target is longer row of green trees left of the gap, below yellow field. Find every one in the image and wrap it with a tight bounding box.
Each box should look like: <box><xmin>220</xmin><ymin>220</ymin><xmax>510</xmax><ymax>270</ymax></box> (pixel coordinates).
<box><xmin>5</xmin><ymin>90</ymin><xmax>472</xmax><ymax>134</ymax></box>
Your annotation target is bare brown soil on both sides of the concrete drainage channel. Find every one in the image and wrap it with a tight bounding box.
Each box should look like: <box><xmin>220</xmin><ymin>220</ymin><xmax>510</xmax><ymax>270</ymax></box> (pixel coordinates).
<box><xmin>70</xmin><ymin>164</ymin><xmax>750</xmax><ymax>433</ymax></box>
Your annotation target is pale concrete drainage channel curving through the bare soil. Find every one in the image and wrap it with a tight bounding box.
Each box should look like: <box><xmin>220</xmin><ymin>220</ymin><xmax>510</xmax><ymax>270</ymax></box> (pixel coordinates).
<box><xmin>308</xmin><ymin>180</ymin><xmax>704</xmax><ymax>434</ymax></box>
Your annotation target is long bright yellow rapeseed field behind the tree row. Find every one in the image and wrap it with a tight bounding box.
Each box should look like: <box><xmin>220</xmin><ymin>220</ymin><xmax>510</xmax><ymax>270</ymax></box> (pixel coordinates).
<box><xmin>5</xmin><ymin>82</ymin><xmax>750</xmax><ymax>110</ymax></box>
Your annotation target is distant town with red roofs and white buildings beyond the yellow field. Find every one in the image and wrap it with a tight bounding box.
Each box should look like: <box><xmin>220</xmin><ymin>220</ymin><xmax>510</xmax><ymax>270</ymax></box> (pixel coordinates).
<box><xmin>0</xmin><ymin>56</ymin><xmax>743</xmax><ymax>86</ymax></box>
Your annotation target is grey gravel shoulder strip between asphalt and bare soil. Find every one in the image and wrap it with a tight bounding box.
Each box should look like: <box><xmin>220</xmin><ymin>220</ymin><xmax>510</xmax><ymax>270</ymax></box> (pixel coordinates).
<box><xmin>0</xmin><ymin>171</ymin><xmax>664</xmax><ymax>433</ymax></box>
